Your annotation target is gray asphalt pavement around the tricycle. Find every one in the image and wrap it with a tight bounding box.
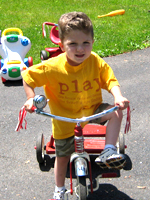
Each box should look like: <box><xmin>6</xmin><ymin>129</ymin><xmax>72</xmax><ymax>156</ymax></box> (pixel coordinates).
<box><xmin>0</xmin><ymin>48</ymin><xmax>150</xmax><ymax>200</ymax></box>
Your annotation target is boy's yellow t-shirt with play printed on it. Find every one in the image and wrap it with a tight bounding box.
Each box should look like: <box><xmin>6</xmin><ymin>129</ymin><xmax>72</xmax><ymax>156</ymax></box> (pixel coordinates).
<box><xmin>22</xmin><ymin>52</ymin><xmax>119</xmax><ymax>139</ymax></box>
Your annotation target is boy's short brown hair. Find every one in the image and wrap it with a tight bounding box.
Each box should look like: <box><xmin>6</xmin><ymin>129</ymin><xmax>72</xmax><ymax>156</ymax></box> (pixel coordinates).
<box><xmin>58</xmin><ymin>12</ymin><xmax>94</xmax><ymax>41</ymax></box>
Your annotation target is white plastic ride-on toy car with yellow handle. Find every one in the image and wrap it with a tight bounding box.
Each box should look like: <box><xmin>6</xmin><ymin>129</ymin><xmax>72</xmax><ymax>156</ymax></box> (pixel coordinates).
<box><xmin>0</xmin><ymin>28</ymin><xmax>33</xmax><ymax>83</ymax></box>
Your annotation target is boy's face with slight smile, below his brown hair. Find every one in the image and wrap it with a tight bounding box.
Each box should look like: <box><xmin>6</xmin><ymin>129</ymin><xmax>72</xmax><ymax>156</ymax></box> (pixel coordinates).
<box><xmin>60</xmin><ymin>30</ymin><xmax>94</xmax><ymax>66</ymax></box>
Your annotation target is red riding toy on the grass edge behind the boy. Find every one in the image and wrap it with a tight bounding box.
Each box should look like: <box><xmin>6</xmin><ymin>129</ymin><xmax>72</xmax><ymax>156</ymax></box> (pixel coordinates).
<box><xmin>40</xmin><ymin>22</ymin><xmax>62</xmax><ymax>61</ymax></box>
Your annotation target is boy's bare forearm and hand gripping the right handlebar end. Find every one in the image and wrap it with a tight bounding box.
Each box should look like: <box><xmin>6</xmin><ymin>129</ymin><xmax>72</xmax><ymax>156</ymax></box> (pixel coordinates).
<box><xmin>110</xmin><ymin>86</ymin><xmax>129</xmax><ymax>110</ymax></box>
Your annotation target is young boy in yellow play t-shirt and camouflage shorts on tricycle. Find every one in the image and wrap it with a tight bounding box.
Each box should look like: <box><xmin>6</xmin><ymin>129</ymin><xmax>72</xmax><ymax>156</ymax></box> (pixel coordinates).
<box><xmin>22</xmin><ymin>12</ymin><xmax>129</xmax><ymax>199</ymax></box>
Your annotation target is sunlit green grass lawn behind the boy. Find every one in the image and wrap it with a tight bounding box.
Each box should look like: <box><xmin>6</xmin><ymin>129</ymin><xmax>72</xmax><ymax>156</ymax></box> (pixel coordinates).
<box><xmin>0</xmin><ymin>0</ymin><xmax>150</xmax><ymax>64</ymax></box>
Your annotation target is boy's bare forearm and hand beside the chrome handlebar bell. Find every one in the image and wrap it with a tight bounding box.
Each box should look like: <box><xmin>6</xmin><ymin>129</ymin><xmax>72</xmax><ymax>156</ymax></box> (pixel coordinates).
<box><xmin>23</xmin><ymin>80</ymin><xmax>35</xmax><ymax>113</ymax></box>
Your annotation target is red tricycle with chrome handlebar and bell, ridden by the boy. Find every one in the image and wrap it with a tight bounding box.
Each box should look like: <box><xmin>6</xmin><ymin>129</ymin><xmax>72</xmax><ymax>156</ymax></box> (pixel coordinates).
<box><xmin>30</xmin><ymin>95</ymin><xmax>132</xmax><ymax>200</ymax></box>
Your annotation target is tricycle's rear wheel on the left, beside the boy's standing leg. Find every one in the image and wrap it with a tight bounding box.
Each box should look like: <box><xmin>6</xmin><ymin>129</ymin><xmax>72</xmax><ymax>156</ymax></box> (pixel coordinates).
<box><xmin>36</xmin><ymin>134</ymin><xmax>45</xmax><ymax>164</ymax></box>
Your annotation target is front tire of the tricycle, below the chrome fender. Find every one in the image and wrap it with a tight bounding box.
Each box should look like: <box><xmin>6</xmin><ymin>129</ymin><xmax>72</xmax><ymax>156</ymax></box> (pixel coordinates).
<box><xmin>77</xmin><ymin>176</ymin><xmax>87</xmax><ymax>200</ymax></box>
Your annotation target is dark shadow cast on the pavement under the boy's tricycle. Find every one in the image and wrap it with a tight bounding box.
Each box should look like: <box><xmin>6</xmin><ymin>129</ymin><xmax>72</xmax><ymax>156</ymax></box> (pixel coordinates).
<box><xmin>39</xmin><ymin>155</ymin><xmax>134</xmax><ymax>200</ymax></box>
